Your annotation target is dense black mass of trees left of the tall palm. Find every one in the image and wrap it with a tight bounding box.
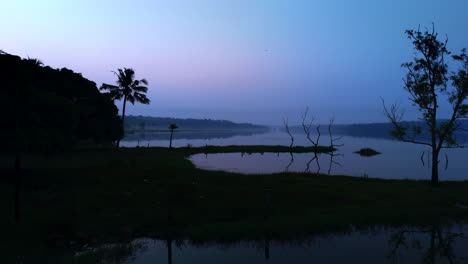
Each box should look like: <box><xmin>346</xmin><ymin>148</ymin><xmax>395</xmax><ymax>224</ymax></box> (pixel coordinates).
<box><xmin>0</xmin><ymin>52</ymin><xmax>123</xmax><ymax>152</ymax></box>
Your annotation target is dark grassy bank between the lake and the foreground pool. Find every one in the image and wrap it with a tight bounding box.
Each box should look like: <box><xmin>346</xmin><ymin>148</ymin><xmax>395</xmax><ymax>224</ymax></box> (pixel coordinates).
<box><xmin>0</xmin><ymin>146</ymin><xmax>468</xmax><ymax>252</ymax></box>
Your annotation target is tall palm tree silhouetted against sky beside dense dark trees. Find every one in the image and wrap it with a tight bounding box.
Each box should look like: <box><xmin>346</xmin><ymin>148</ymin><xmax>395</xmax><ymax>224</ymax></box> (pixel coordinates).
<box><xmin>99</xmin><ymin>68</ymin><xmax>150</xmax><ymax>147</ymax></box>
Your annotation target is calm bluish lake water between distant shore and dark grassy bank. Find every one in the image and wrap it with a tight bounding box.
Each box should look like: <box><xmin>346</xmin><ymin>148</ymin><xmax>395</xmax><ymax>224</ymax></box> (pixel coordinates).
<box><xmin>122</xmin><ymin>130</ymin><xmax>468</xmax><ymax>181</ymax></box>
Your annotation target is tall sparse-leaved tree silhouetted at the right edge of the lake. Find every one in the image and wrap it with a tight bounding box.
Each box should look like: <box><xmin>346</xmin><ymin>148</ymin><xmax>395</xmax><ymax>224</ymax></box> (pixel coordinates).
<box><xmin>384</xmin><ymin>26</ymin><xmax>468</xmax><ymax>185</ymax></box>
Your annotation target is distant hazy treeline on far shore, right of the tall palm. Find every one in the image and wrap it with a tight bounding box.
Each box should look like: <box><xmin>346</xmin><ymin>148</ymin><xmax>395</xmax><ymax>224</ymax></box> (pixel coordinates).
<box><xmin>125</xmin><ymin>116</ymin><xmax>268</xmax><ymax>130</ymax></box>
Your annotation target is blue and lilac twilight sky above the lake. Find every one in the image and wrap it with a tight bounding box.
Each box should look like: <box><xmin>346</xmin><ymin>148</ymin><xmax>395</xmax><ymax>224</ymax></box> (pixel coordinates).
<box><xmin>0</xmin><ymin>0</ymin><xmax>468</xmax><ymax>125</ymax></box>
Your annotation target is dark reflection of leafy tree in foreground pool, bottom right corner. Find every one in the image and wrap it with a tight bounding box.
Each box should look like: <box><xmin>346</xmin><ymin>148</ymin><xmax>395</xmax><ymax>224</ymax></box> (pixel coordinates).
<box><xmin>388</xmin><ymin>225</ymin><xmax>467</xmax><ymax>264</ymax></box>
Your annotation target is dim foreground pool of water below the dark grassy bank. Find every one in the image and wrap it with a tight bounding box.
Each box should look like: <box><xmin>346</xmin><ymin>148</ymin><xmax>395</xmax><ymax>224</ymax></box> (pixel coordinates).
<box><xmin>76</xmin><ymin>225</ymin><xmax>468</xmax><ymax>264</ymax></box>
